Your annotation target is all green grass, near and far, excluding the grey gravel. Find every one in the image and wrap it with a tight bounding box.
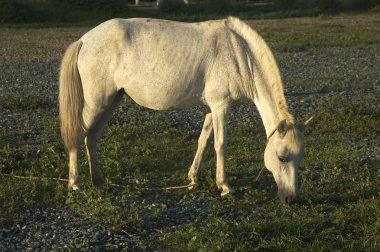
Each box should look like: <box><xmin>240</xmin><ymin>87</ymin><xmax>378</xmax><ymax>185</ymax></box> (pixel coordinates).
<box><xmin>0</xmin><ymin>15</ymin><xmax>380</xmax><ymax>251</ymax></box>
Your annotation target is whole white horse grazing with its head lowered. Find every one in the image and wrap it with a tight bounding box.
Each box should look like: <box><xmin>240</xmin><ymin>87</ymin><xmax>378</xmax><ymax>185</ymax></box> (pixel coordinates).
<box><xmin>59</xmin><ymin>17</ymin><xmax>312</xmax><ymax>203</ymax></box>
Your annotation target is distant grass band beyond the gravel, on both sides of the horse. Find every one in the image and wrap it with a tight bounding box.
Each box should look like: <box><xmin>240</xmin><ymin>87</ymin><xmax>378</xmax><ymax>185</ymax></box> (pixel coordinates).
<box><xmin>0</xmin><ymin>14</ymin><xmax>380</xmax><ymax>57</ymax></box>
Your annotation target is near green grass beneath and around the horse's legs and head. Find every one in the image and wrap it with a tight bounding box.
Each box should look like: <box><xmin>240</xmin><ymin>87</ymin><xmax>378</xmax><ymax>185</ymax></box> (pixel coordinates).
<box><xmin>0</xmin><ymin>95</ymin><xmax>380</xmax><ymax>251</ymax></box>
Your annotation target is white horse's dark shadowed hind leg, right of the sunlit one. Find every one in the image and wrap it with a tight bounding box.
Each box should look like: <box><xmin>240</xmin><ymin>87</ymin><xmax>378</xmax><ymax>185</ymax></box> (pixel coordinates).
<box><xmin>85</xmin><ymin>91</ymin><xmax>124</xmax><ymax>186</ymax></box>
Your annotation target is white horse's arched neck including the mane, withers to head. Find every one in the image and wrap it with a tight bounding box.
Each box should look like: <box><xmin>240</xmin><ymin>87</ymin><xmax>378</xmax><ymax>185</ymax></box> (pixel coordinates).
<box><xmin>227</xmin><ymin>17</ymin><xmax>294</xmax><ymax>136</ymax></box>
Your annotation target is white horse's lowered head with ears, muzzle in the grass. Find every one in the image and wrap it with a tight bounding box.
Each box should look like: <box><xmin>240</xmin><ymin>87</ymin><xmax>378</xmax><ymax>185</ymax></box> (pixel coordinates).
<box><xmin>264</xmin><ymin>118</ymin><xmax>311</xmax><ymax>204</ymax></box>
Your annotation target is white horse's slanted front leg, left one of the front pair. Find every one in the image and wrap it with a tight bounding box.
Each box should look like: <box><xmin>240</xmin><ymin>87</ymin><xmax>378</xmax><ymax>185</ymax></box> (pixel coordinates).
<box><xmin>188</xmin><ymin>113</ymin><xmax>213</xmax><ymax>190</ymax></box>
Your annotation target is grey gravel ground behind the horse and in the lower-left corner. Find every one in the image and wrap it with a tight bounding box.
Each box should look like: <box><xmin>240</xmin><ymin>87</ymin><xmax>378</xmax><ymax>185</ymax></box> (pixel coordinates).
<box><xmin>0</xmin><ymin>39</ymin><xmax>380</xmax><ymax>251</ymax></box>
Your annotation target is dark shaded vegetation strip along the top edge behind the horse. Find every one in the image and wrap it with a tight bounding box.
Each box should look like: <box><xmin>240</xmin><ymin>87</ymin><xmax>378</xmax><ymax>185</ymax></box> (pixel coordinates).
<box><xmin>0</xmin><ymin>0</ymin><xmax>380</xmax><ymax>23</ymax></box>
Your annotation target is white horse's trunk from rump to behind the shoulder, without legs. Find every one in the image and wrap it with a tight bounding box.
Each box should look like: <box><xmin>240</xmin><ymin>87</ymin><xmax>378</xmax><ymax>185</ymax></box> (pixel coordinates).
<box><xmin>79</xmin><ymin>19</ymin><xmax>236</xmax><ymax>110</ymax></box>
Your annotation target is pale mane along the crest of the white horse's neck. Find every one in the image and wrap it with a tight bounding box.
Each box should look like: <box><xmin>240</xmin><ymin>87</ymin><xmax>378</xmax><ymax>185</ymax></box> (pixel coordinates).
<box><xmin>226</xmin><ymin>17</ymin><xmax>294</xmax><ymax>123</ymax></box>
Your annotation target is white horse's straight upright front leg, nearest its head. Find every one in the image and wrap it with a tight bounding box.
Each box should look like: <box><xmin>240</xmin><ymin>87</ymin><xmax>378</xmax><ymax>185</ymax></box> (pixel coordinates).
<box><xmin>211</xmin><ymin>104</ymin><xmax>234</xmax><ymax>196</ymax></box>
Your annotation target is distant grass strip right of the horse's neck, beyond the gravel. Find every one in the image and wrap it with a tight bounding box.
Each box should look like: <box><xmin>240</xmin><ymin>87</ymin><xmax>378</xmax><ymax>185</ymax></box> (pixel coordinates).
<box><xmin>249</xmin><ymin>15</ymin><xmax>380</xmax><ymax>51</ymax></box>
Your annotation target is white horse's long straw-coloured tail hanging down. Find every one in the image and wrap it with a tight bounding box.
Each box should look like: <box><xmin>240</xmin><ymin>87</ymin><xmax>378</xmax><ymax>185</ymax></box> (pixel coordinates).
<box><xmin>59</xmin><ymin>41</ymin><xmax>84</xmax><ymax>150</ymax></box>
